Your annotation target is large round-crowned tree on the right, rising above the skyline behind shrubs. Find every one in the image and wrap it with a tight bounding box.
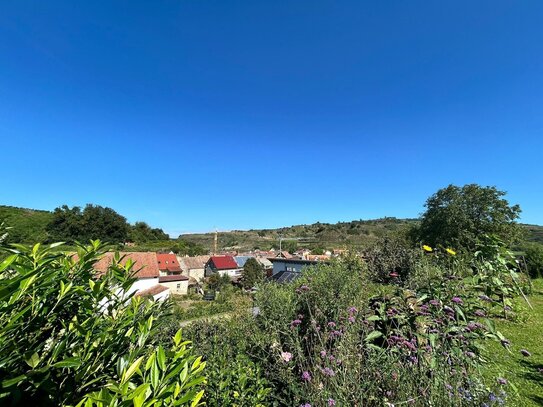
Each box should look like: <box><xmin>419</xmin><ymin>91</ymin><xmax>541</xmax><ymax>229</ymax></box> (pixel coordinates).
<box><xmin>419</xmin><ymin>184</ymin><xmax>521</xmax><ymax>251</ymax></box>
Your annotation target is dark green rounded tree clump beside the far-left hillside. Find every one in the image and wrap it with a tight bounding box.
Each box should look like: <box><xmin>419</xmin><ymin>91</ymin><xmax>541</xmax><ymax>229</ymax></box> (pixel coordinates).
<box><xmin>47</xmin><ymin>204</ymin><xmax>130</xmax><ymax>243</ymax></box>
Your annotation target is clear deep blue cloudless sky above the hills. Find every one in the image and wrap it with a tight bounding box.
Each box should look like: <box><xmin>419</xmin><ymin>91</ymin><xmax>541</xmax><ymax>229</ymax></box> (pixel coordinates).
<box><xmin>0</xmin><ymin>0</ymin><xmax>543</xmax><ymax>235</ymax></box>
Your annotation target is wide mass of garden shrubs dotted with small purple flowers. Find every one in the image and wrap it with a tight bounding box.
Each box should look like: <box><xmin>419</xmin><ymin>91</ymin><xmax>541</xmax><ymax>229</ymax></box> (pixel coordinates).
<box><xmin>178</xmin><ymin>247</ymin><xmax>532</xmax><ymax>406</ymax></box>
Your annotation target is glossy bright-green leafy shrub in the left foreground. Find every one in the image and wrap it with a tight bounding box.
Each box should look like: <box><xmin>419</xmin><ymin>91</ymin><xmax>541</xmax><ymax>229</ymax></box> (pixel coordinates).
<box><xmin>0</xmin><ymin>241</ymin><xmax>204</xmax><ymax>406</ymax></box>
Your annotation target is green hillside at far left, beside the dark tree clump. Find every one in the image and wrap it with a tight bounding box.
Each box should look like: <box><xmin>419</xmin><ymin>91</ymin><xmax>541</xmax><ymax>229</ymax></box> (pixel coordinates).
<box><xmin>0</xmin><ymin>205</ymin><xmax>53</xmax><ymax>243</ymax></box>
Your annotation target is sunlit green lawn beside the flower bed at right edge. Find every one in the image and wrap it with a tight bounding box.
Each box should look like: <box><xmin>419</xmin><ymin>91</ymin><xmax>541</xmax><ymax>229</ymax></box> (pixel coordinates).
<box><xmin>485</xmin><ymin>279</ymin><xmax>543</xmax><ymax>407</ymax></box>
